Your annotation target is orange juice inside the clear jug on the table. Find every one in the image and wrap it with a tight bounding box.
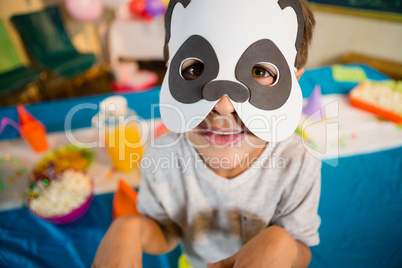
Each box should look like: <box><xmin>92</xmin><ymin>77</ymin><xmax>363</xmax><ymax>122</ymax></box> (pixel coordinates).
<box><xmin>105</xmin><ymin>123</ymin><xmax>144</xmax><ymax>172</ymax></box>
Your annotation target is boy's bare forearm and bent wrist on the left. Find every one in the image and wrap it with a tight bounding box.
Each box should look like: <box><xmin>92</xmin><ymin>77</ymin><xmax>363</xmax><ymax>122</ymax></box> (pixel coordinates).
<box><xmin>92</xmin><ymin>215</ymin><xmax>179</xmax><ymax>268</ymax></box>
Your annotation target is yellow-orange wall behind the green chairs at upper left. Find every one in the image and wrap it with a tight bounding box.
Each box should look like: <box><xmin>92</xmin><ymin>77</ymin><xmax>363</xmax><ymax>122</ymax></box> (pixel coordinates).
<box><xmin>0</xmin><ymin>0</ymin><xmax>101</xmax><ymax>64</ymax></box>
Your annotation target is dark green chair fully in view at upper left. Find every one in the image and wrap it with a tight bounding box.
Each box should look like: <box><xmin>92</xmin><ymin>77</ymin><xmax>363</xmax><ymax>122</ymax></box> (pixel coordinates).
<box><xmin>11</xmin><ymin>6</ymin><xmax>96</xmax><ymax>78</ymax></box>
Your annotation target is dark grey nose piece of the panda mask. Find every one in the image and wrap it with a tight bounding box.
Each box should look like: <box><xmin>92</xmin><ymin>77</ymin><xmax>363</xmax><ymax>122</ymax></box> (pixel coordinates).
<box><xmin>202</xmin><ymin>80</ymin><xmax>250</xmax><ymax>103</ymax></box>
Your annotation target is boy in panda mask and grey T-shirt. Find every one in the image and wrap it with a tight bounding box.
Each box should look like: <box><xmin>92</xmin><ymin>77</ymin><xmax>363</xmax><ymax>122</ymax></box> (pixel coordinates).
<box><xmin>94</xmin><ymin>0</ymin><xmax>321</xmax><ymax>268</ymax></box>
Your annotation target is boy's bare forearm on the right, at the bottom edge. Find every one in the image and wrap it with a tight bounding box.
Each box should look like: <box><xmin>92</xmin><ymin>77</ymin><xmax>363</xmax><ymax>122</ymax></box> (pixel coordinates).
<box><xmin>207</xmin><ymin>226</ymin><xmax>311</xmax><ymax>268</ymax></box>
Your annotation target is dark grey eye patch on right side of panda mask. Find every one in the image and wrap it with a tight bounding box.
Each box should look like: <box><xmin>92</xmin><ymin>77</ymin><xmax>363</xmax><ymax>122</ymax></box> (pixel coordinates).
<box><xmin>236</xmin><ymin>39</ymin><xmax>292</xmax><ymax>111</ymax></box>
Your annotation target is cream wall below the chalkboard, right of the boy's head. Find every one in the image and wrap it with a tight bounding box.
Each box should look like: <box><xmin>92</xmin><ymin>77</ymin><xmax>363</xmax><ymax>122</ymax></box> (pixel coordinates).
<box><xmin>306</xmin><ymin>10</ymin><xmax>402</xmax><ymax>67</ymax></box>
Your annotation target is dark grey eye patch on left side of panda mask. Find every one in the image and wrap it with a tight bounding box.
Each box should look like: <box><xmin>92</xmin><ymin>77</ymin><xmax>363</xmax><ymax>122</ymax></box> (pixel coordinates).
<box><xmin>169</xmin><ymin>35</ymin><xmax>219</xmax><ymax>104</ymax></box>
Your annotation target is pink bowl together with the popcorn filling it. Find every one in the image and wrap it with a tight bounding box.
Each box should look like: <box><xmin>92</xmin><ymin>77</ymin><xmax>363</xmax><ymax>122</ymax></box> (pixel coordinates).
<box><xmin>27</xmin><ymin>169</ymin><xmax>93</xmax><ymax>224</ymax></box>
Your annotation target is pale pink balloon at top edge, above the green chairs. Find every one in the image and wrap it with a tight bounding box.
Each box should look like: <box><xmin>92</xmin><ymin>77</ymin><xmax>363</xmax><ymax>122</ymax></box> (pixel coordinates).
<box><xmin>66</xmin><ymin>0</ymin><xmax>103</xmax><ymax>22</ymax></box>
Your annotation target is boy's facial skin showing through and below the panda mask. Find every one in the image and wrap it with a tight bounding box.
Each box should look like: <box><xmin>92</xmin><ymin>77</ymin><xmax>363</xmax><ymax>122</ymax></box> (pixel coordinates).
<box><xmin>182</xmin><ymin>66</ymin><xmax>304</xmax><ymax>177</ymax></box>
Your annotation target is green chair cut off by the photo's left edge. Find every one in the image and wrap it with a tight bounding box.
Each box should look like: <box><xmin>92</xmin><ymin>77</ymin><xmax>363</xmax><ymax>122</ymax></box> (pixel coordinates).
<box><xmin>0</xmin><ymin>19</ymin><xmax>41</xmax><ymax>99</ymax></box>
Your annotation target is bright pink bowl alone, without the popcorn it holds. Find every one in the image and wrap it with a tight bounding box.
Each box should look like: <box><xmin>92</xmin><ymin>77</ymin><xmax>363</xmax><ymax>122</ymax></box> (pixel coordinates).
<box><xmin>28</xmin><ymin>171</ymin><xmax>94</xmax><ymax>224</ymax></box>
